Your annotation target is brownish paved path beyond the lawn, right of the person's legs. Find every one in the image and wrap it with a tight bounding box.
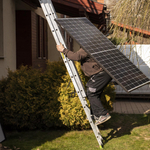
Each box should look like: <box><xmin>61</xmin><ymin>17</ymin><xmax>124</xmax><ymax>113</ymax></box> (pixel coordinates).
<box><xmin>113</xmin><ymin>100</ymin><xmax>150</xmax><ymax>114</ymax></box>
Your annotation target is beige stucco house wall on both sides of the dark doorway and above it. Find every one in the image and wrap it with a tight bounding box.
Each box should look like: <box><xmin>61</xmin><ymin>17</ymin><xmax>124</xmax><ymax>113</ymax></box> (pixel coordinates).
<box><xmin>0</xmin><ymin>0</ymin><xmax>60</xmax><ymax>79</ymax></box>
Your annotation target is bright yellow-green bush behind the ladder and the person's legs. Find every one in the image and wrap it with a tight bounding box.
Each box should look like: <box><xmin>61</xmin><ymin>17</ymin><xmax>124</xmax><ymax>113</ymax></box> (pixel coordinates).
<box><xmin>58</xmin><ymin>63</ymin><xmax>115</xmax><ymax>129</ymax></box>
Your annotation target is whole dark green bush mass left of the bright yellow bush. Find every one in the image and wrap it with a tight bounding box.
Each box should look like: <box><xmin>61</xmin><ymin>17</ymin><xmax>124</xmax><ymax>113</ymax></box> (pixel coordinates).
<box><xmin>0</xmin><ymin>62</ymin><xmax>66</xmax><ymax>129</ymax></box>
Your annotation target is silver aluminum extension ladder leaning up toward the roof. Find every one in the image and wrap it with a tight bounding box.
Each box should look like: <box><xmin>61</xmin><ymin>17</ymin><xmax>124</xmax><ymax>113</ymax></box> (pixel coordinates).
<box><xmin>39</xmin><ymin>0</ymin><xmax>103</xmax><ymax>149</ymax></box>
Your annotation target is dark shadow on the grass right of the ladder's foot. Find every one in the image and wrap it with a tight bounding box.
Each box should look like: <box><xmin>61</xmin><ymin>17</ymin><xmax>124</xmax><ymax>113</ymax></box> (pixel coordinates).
<box><xmin>99</xmin><ymin>113</ymin><xmax>150</xmax><ymax>145</ymax></box>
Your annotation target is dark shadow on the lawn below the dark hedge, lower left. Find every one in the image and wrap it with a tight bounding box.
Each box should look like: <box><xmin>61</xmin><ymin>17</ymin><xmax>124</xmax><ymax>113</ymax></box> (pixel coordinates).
<box><xmin>2</xmin><ymin>129</ymin><xmax>68</xmax><ymax>150</ymax></box>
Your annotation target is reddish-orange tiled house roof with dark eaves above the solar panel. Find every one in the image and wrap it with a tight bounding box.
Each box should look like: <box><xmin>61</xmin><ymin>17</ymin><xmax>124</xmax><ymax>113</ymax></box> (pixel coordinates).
<box><xmin>22</xmin><ymin>0</ymin><xmax>106</xmax><ymax>25</ymax></box>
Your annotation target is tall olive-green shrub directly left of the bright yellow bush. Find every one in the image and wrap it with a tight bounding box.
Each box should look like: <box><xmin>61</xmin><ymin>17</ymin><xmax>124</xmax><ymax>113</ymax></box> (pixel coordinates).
<box><xmin>43</xmin><ymin>61</ymin><xmax>66</xmax><ymax>127</ymax></box>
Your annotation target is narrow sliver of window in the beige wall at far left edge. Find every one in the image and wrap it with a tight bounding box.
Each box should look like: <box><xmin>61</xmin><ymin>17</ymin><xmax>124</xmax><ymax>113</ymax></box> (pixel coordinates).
<box><xmin>0</xmin><ymin>1</ymin><xmax>4</xmax><ymax>58</ymax></box>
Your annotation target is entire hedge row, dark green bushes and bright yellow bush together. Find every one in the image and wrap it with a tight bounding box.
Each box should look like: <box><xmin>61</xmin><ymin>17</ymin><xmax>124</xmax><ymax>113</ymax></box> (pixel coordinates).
<box><xmin>0</xmin><ymin>61</ymin><xmax>115</xmax><ymax>129</ymax></box>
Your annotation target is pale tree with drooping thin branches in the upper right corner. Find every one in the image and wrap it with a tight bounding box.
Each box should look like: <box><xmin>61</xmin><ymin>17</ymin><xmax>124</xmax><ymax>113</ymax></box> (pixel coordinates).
<box><xmin>110</xmin><ymin>0</ymin><xmax>150</xmax><ymax>44</ymax></box>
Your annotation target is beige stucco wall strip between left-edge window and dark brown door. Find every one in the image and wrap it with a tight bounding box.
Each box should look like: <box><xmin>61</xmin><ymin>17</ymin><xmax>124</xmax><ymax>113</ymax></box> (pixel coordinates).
<box><xmin>0</xmin><ymin>0</ymin><xmax>16</xmax><ymax>78</ymax></box>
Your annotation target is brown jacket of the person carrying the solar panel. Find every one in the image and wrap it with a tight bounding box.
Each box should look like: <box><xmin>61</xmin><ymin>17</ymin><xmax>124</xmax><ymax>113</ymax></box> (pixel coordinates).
<box><xmin>63</xmin><ymin>48</ymin><xmax>103</xmax><ymax>77</ymax></box>
